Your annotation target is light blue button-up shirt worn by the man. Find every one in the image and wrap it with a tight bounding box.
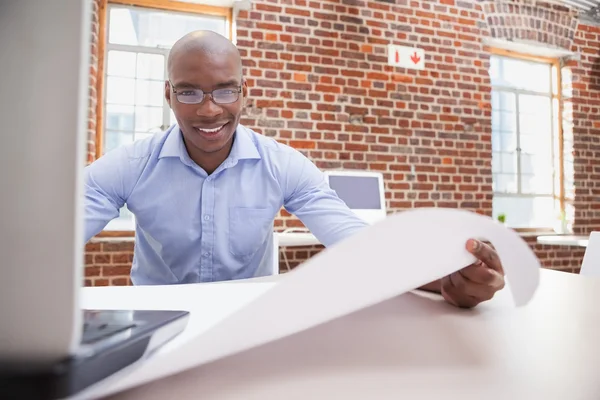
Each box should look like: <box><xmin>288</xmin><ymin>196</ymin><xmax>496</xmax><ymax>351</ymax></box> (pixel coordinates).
<box><xmin>85</xmin><ymin>125</ymin><xmax>367</xmax><ymax>285</ymax></box>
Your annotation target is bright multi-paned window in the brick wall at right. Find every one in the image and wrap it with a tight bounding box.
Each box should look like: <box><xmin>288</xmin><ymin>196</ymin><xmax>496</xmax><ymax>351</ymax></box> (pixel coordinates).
<box><xmin>490</xmin><ymin>55</ymin><xmax>563</xmax><ymax>228</ymax></box>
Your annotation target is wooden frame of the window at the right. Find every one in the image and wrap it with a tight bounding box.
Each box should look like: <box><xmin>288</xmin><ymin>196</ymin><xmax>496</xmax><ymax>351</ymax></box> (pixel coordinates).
<box><xmin>488</xmin><ymin>48</ymin><xmax>566</xmax><ymax>232</ymax></box>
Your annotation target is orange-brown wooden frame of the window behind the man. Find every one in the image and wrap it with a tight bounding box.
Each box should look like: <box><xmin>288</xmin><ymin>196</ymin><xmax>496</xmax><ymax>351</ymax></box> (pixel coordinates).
<box><xmin>94</xmin><ymin>0</ymin><xmax>234</xmax><ymax>237</ymax></box>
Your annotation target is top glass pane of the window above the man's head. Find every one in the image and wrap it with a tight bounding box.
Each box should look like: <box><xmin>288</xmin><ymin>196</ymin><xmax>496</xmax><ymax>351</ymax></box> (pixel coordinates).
<box><xmin>108</xmin><ymin>6</ymin><xmax>228</xmax><ymax>48</ymax></box>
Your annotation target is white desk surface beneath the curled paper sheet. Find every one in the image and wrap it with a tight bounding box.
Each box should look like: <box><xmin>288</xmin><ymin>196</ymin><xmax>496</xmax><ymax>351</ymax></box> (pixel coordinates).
<box><xmin>101</xmin><ymin>270</ymin><xmax>600</xmax><ymax>400</ymax></box>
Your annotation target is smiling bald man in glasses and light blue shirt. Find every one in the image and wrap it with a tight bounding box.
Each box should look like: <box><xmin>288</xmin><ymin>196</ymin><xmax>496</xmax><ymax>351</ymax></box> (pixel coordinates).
<box><xmin>85</xmin><ymin>31</ymin><xmax>504</xmax><ymax>307</ymax></box>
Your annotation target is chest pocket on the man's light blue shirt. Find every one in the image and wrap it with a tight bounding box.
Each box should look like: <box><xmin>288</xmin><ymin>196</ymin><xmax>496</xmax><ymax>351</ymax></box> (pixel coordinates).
<box><xmin>229</xmin><ymin>207</ymin><xmax>275</xmax><ymax>259</ymax></box>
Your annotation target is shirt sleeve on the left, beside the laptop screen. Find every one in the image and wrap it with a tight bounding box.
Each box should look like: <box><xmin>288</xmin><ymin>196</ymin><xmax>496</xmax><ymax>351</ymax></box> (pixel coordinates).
<box><xmin>84</xmin><ymin>146</ymin><xmax>134</xmax><ymax>243</ymax></box>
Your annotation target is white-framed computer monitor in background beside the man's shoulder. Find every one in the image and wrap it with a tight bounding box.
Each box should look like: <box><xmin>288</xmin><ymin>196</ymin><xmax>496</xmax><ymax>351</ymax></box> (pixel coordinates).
<box><xmin>325</xmin><ymin>170</ymin><xmax>386</xmax><ymax>224</ymax></box>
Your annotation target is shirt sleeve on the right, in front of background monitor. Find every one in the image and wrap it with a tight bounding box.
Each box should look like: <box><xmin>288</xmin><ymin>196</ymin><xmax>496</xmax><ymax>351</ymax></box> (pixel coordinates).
<box><xmin>284</xmin><ymin>150</ymin><xmax>368</xmax><ymax>247</ymax></box>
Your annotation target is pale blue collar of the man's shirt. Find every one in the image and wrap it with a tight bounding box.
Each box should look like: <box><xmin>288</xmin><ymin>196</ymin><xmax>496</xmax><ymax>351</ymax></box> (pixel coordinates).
<box><xmin>158</xmin><ymin>124</ymin><xmax>261</xmax><ymax>165</ymax></box>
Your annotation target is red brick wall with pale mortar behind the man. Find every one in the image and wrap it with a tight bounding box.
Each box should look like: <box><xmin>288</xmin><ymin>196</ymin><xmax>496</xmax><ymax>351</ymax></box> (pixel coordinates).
<box><xmin>86</xmin><ymin>0</ymin><xmax>600</xmax><ymax>284</ymax></box>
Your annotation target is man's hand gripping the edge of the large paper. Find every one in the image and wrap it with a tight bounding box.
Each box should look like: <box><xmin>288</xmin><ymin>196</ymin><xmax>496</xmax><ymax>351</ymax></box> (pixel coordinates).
<box><xmin>441</xmin><ymin>239</ymin><xmax>504</xmax><ymax>308</ymax></box>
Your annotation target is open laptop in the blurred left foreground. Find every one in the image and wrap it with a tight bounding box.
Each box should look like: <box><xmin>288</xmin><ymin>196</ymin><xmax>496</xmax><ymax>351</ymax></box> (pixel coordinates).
<box><xmin>0</xmin><ymin>0</ymin><xmax>188</xmax><ymax>399</ymax></box>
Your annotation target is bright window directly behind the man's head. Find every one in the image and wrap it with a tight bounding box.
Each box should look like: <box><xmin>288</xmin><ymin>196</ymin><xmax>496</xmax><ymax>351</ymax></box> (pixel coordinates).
<box><xmin>96</xmin><ymin>0</ymin><xmax>231</xmax><ymax>231</ymax></box>
